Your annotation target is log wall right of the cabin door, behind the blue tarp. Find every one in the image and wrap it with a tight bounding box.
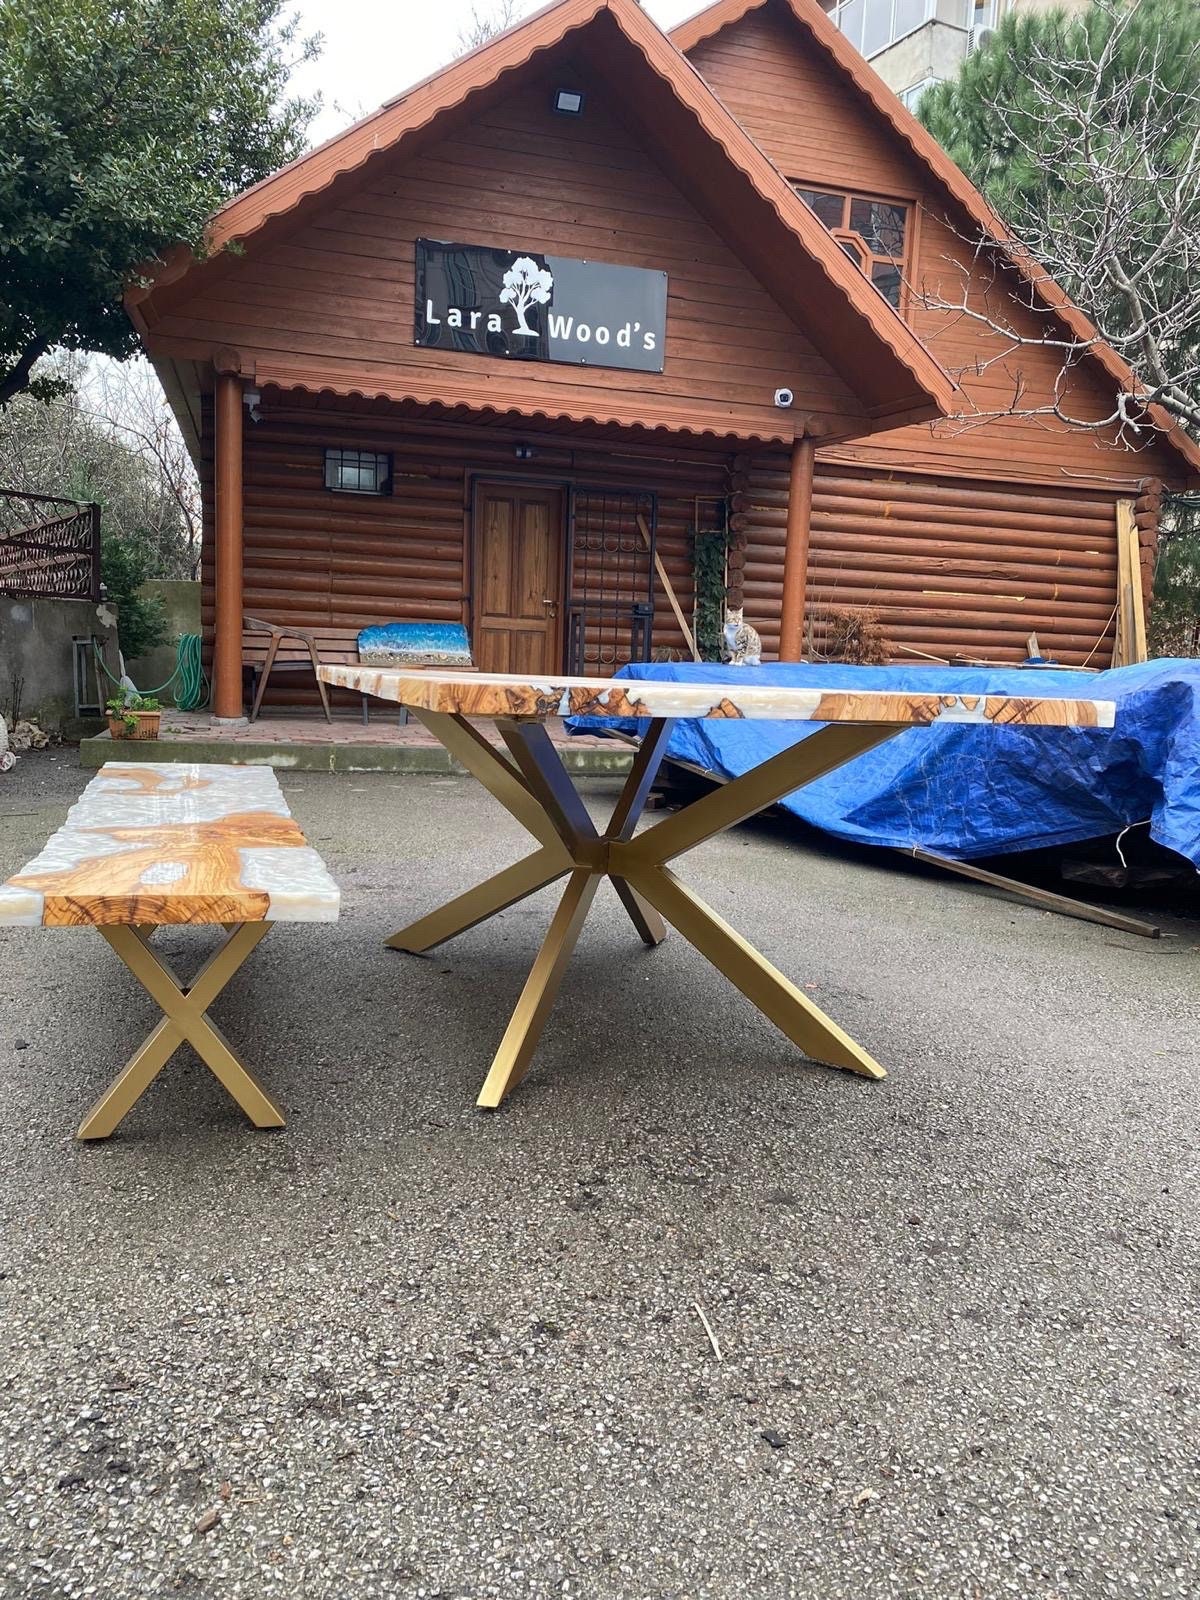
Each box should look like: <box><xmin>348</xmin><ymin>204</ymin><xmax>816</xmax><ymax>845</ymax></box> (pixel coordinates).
<box><xmin>733</xmin><ymin>453</ymin><xmax>1117</xmax><ymax>667</ymax></box>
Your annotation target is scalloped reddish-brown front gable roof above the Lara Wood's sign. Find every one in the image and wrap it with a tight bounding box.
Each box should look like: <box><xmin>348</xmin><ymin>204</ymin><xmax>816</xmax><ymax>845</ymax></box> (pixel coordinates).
<box><xmin>126</xmin><ymin>0</ymin><xmax>955</xmax><ymax>432</ymax></box>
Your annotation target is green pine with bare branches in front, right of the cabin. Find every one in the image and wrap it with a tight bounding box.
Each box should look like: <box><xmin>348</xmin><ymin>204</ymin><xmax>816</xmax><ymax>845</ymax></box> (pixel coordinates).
<box><xmin>920</xmin><ymin>0</ymin><xmax>1200</xmax><ymax>445</ymax></box>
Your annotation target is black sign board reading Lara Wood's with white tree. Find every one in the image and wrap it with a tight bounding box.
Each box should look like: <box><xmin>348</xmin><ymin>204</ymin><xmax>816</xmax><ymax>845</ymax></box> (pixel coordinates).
<box><xmin>414</xmin><ymin>238</ymin><xmax>667</xmax><ymax>373</ymax></box>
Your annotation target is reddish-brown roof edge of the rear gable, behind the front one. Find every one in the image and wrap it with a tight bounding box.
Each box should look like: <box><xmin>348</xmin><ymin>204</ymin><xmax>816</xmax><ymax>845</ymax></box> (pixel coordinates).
<box><xmin>669</xmin><ymin>0</ymin><xmax>1200</xmax><ymax>477</ymax></box>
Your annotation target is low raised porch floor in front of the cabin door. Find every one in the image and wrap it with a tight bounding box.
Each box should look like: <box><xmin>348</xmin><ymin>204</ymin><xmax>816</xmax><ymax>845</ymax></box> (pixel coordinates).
<box><xmin>80</xmin><ymin>704</ymin><xmax>632</xmax><ymax>776</ymax></box>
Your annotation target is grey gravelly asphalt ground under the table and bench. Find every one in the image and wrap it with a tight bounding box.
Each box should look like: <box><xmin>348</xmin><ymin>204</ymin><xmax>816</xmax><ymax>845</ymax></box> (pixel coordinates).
<box><xmin>0</xmin><ymin>752</ymin><xmax>1200</xmax><ymax>1600</ymax></box>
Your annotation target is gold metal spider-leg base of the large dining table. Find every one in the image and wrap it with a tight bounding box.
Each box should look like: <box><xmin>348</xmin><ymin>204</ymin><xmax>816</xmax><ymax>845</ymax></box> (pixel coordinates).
<box><xmin>387</xmin><ymin>709</ymin><xmax>902</xmax><ymax>1107</ymax></box>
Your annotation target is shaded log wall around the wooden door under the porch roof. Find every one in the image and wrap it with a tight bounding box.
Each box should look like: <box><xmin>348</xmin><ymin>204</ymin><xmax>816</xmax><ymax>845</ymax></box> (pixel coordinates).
<box><xmin>202</xmin><ymin>392</ymin><xmax>731</xmax><ymax>704</ymax></box>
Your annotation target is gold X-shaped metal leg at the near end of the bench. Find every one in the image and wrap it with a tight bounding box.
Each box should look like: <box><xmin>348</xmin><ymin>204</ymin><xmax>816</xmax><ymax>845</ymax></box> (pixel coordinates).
<box><xmin>78</xmin><ymin>922</ymin><xmax>283</xmax><ymax>1139</ymax></box>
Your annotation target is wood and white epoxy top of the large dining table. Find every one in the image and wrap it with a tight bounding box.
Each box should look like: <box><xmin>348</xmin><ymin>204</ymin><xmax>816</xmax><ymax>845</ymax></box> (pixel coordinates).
<box><xmin>320</xmin><ymin>666</ymin><xmax>1115</xmax><ymax>728</ymax></box>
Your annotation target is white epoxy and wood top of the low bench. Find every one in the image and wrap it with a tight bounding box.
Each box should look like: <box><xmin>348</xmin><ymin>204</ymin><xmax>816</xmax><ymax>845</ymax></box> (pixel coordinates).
<box><xmin>0</xmin><ymin>762</ymin><xmax>341</xmax><ymax>928</ymax></box>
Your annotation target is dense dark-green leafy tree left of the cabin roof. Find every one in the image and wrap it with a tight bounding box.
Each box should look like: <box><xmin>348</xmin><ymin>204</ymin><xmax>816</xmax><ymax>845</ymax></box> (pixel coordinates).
<box><xmin>0</xmin><ymin>0</ymin><xmax>318</xmax><ymax>405</ymax></box>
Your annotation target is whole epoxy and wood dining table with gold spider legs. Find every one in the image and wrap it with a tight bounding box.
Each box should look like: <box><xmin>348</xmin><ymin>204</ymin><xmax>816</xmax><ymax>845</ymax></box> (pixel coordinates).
<box><xmin>320</xmin><ymin>666</ymin><xmax>1114</xmax><ymax>1107</ymax></box>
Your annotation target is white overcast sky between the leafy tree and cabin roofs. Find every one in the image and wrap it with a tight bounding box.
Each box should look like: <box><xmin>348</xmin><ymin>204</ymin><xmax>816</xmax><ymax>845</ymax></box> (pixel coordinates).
<box><xmin>293</xmin><ymin>0</ymin><xmax>706</xmax><ymax>144</ymax></box>
